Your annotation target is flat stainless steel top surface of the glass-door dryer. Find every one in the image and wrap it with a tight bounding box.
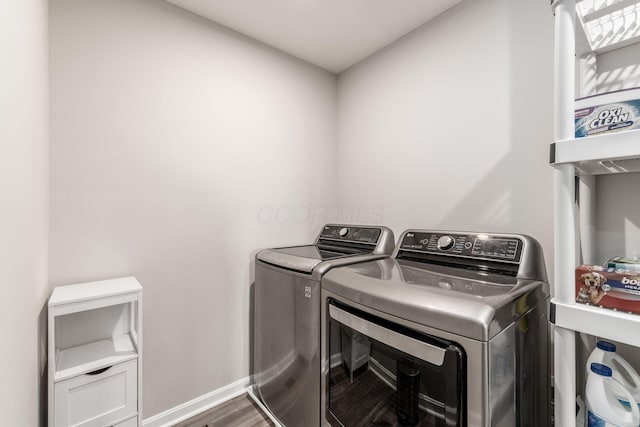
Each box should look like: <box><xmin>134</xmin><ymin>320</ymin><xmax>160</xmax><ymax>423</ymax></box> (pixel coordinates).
<box><xmin>322</xmin><ymin>258</ymin><xmax>549</xmax><ymax>341</ymax></box>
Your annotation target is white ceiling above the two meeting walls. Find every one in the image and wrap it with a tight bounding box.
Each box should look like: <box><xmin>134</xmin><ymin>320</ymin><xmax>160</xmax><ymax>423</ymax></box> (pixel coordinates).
<box><xmin>162</xmin><ymin>0</ymin><xmax>462</xmax><ymax>73</ymax></box>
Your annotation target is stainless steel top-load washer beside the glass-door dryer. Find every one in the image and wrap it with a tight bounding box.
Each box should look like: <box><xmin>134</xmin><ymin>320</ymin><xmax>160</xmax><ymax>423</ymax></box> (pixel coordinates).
<box><xmin>252</xmin><ymin>224</ymin><xmax>395</xmax><ymax>427</ymax></box>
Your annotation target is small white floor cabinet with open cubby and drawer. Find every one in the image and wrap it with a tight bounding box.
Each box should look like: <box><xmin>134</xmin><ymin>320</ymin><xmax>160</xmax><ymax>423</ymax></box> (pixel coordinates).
<box><xmin>48</xmin><ymin>277</ymin><xmax>142</xmax><ymax>427</ymax></box>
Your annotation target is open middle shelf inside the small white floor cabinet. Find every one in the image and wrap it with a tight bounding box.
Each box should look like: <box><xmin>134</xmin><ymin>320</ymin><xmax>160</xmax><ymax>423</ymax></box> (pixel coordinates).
<box><xmin>54</xmin><ymin>334</ymin><xmax>138</xmax><ymax>382</ymax></box>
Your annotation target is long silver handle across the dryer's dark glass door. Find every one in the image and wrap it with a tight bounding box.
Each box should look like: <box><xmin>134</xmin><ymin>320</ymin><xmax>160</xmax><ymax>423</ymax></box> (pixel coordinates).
<box><xmin>329</xmin><ymin>305</ymin><xmax>445</xmax><ymax>366</ymax></box>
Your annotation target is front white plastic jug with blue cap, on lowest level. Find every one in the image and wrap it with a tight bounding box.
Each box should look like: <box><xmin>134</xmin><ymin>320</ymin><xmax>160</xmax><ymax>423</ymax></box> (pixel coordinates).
<box><xmin>585</xmin><ymin>363</ymin><xmax>640</xmax><ymax>427</ymax></box>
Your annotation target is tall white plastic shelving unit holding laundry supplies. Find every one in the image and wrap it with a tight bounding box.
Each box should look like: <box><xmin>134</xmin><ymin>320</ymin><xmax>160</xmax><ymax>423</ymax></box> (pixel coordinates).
<box><xmin>551</xmin><ymin>0</ymin><xmax>640</xmax><ymax>427</ymax></box>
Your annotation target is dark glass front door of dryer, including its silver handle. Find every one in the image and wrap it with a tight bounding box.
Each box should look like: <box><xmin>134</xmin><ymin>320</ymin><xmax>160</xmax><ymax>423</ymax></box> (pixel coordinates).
<box><xmin>326</xmin><ymin>301</ymin><xmax>466</xmax><ymax>427</ymax></box>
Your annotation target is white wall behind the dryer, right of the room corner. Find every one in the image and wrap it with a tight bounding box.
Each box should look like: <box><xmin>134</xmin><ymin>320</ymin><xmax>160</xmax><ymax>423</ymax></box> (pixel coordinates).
<box><xmin>338</xmin><ymin>0</ymin><xmax>553</xmax><ymax>276</ymax></box>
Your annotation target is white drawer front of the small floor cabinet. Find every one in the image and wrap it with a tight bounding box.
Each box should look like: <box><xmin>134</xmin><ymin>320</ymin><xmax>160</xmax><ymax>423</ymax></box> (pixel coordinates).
<box><xmin>55</xmin><ymin>360</ymin><xmax>138</xmax><ymax>427</ymax></box>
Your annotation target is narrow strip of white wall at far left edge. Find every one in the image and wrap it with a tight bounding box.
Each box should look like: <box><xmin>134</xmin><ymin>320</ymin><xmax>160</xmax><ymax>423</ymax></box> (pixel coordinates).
<box><xmin>0</xmin><ymin>0</ymin><xmax>49</xmax><ymax>426</ymax></box>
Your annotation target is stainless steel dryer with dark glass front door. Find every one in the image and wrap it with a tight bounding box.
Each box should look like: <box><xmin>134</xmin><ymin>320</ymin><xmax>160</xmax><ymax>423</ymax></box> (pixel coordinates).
<box><xmin>322</xmin><ymin>230</ymin><xmax>550</xmax><ymax>427</ymax></box>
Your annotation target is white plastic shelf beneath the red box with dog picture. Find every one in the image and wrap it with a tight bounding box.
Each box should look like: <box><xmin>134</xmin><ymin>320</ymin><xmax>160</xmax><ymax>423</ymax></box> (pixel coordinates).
<box><xmin>551</xmin><ymin>299</ymin><xmax>640</xmax><ymax>347</ymax></box>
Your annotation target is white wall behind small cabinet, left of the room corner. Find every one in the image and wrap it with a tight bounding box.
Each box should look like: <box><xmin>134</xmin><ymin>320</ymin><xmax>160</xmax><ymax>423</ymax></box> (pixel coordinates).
<box><xmin>50</xmin><ymin>0</ymin><xmax>336</xmax><ymax>418</ymax></box>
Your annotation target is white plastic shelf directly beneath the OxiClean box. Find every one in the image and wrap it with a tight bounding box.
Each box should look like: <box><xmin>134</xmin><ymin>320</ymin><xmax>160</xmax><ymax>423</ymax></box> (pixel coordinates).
<box><xmin>550</xmin><ymin>129</ymin><xmax>640</xmax><ymax>175</ymax></box>
